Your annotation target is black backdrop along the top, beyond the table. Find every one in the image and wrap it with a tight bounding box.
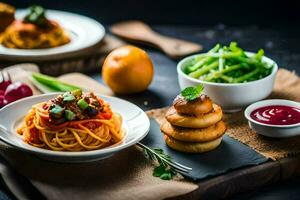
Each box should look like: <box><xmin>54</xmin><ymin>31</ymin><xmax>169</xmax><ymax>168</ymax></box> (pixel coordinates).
<box><xmin>4</xmin><ymin>0</ymin><xmax>300</xmax><ymax>28</ymax></box>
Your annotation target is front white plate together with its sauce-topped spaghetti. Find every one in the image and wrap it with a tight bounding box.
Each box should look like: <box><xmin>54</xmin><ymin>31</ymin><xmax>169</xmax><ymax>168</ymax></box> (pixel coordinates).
<box><xmin>0</xmin><ymin>90</ymin><xmax>150</xmax><ymax>162</ymax></box>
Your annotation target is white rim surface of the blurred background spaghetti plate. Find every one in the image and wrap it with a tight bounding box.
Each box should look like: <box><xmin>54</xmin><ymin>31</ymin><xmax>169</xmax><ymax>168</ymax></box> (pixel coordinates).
<box><xmin>0</xmin><ymin>9</ymin><xmax>105</xmax><ymax>57</ymax></box>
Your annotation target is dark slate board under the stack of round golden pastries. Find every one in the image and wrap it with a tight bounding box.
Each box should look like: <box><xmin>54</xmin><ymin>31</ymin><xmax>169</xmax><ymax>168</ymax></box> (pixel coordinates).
<box><xmin>141</xmin><ymin>119</ymin><xmax>268</xmax><ymax>181</ymax></box>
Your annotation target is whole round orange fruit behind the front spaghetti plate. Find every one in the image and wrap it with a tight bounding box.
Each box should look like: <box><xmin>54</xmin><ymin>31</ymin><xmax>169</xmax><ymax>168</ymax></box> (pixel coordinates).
<box><xmin>102</xmin><ymin>45</ymin><xmax>154</xmax><ymax>94</ymax></box>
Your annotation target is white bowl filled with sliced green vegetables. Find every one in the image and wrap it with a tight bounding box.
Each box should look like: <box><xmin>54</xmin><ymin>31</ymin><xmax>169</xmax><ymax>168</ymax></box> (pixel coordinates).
<box><xmin>177</xmin><ymin>43</ymin><xmax>278</xmax><ymax>112</ymax></box>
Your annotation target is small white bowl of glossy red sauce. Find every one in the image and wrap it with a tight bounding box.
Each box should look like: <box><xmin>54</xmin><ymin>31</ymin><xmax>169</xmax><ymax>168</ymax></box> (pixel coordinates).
<box><xmin>244</xmin><ymin>99</ymin><xmax>300</xmax><ymax>138</ymax></box>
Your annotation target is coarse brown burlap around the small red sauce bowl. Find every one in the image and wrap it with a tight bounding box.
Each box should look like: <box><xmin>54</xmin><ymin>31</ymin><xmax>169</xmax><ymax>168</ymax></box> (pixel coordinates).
<box><xmin>224</xmin><ymin>69</ymin><xmax>300</xmax><ymax>160</ymax></box>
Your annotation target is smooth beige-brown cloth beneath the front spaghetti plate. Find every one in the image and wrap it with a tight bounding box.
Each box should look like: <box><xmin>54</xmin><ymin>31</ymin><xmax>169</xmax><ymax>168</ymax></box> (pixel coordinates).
<box><xmin>1</xmin><ymin>147</ymin><xmax>197</xmax><ymax>200</ymax></box>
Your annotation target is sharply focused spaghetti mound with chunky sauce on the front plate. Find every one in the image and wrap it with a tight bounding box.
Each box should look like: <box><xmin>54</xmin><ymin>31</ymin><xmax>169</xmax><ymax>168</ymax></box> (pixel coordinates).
<box><xmin>17</xmin><ymin>90</ymin><xmax>124</xmax><ymax>151</ymax></box>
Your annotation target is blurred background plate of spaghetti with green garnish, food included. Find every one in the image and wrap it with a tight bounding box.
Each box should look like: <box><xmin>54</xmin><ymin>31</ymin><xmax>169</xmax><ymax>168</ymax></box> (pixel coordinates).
<box><xmin>0</xmin><ymin>6</ymin><xmax>105</xmax><ymax>61</ymax></box>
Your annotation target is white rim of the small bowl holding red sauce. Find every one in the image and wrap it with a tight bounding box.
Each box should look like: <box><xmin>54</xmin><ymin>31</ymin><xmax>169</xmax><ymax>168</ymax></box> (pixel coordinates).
<box><xmin>244</xmin><ymin>99</ymin><xmax>300</xmax><ymax>128</ymax></box>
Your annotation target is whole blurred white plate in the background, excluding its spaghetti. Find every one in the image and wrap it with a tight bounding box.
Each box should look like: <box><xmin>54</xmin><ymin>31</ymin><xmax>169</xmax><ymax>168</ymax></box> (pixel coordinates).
<box><xmin>0</xmin><ymin>9</ymin><xmax>105</xmax><ymax>61</ymax></box>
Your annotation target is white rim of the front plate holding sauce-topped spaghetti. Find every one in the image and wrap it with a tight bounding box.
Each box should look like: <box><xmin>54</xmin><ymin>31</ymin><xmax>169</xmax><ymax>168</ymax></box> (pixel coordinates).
<box><xmin>0</xmin><ymin>93</ymin><xmax>150</xmax><ymax>157</ymax></box>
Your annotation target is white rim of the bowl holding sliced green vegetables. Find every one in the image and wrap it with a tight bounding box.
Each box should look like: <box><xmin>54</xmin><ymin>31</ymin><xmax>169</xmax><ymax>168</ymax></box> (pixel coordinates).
<box><xmin>177</xmin><ymin>51</ymin><xmax>278</xmax><ymax>87</ymax></box>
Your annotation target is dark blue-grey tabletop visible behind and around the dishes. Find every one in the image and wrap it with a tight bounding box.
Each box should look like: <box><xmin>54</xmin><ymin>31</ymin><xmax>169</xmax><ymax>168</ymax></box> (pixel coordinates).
<box><xmin>0</xmin><ymin>24</ymin><xmax>300</xmax><ymax>200</ymax></box>
